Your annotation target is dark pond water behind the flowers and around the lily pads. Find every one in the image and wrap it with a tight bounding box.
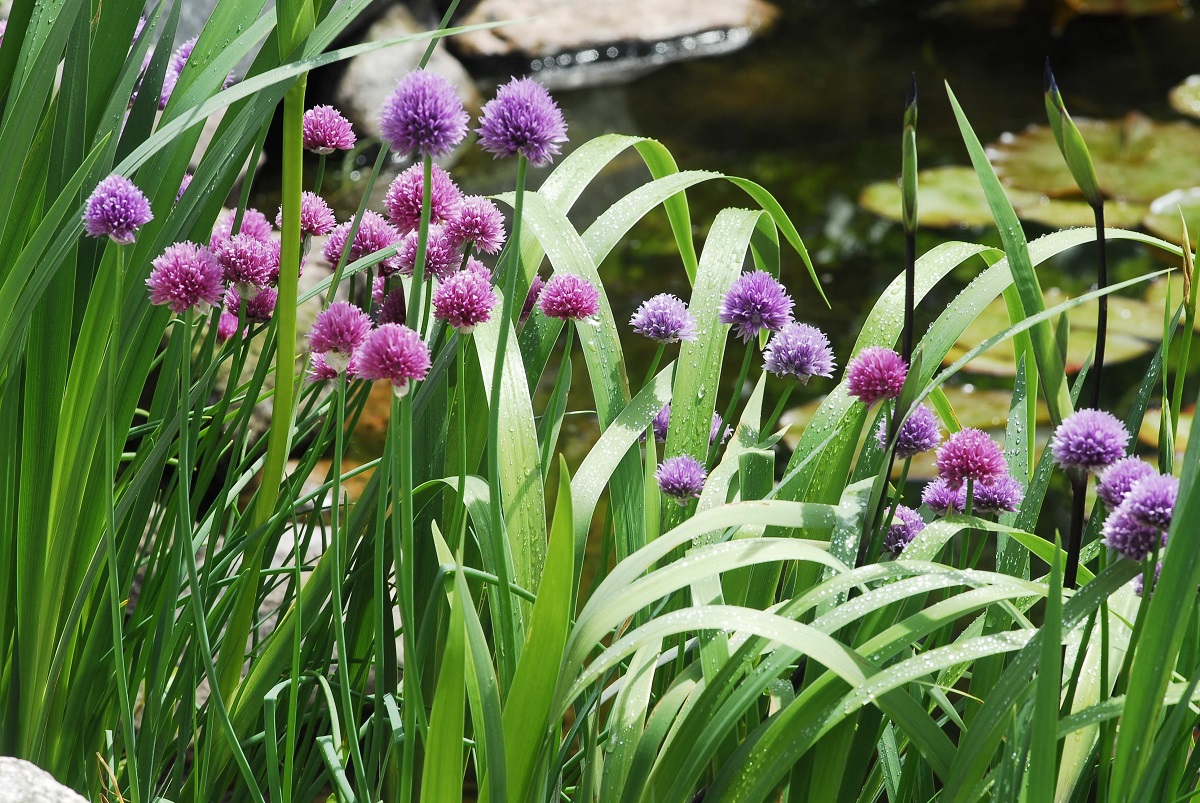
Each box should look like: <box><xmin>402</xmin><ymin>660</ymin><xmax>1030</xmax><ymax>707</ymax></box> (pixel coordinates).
<box><xmin>283</xmin><ymin>0</ymin><xmax>1200</xmax><ymax>482</ymax></box>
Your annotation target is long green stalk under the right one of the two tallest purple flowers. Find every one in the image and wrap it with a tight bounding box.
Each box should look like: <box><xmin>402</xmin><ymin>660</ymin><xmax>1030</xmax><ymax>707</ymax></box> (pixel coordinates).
<box><xmin>487</xmin><ymin>155</ymin><xmax>529</xmax><ymax>689</ymax></box>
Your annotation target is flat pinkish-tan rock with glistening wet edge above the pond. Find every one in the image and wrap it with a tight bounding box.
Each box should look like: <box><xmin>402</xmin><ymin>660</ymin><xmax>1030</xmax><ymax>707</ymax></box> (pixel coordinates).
<box><xmin>451</xmin><ymin>0</ymin><xmax>779</xmax><ymax>88</ymax></box>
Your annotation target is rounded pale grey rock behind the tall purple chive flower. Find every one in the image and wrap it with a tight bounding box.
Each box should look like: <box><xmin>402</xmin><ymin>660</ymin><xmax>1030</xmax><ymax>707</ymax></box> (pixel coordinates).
<box><xmin>335</xmin><ymin>5</ymin><xmax>481</xmax><ymax>137</ymax></box>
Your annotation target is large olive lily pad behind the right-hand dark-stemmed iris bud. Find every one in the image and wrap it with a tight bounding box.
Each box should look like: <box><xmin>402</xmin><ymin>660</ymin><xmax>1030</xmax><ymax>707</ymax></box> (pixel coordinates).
<box><xmin>988</xmin><ymin>112</ymin><xmax>1200</xmax><ymax>203</ymax></box>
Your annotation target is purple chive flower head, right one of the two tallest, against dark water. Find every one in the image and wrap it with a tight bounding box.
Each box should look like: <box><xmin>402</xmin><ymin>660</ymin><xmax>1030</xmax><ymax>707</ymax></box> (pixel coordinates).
<box><xmin>479</xmin><ymin>78</ymin><xmax>566</xmax><ymax>167</ymax></box>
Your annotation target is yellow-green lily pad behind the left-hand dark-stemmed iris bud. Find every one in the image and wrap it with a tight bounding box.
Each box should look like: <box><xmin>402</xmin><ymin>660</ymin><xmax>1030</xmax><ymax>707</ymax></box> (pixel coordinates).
<box><xmin>858</xmin><ymin>166</ymin><xmax>1040</xmax><ymax>228</ymax></box>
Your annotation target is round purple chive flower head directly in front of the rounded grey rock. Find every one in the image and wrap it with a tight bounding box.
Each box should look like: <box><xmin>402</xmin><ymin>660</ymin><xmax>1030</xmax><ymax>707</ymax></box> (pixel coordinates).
<box><xmin>379</xmin><ymin>70</ymin><xmax>467</xmax><ymax>156</ymax></box>
